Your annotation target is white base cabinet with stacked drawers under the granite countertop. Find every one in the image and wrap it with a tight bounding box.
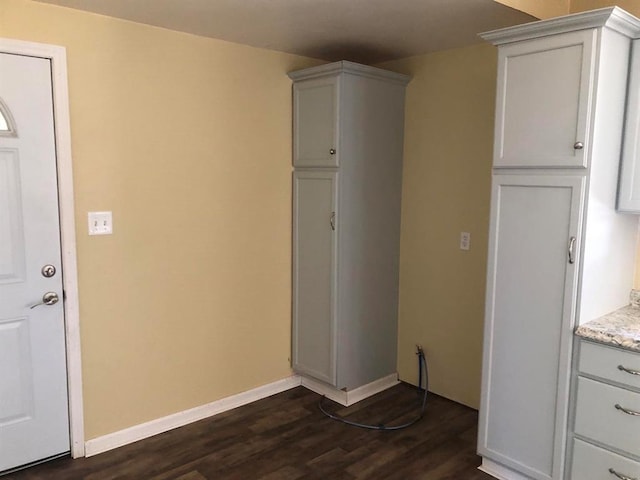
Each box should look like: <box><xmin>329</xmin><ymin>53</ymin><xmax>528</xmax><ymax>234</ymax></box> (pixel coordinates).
<box><xmin>570</xmin><ymin>341</ymin><xmax>640</xmax><ymax>480</ymax></box>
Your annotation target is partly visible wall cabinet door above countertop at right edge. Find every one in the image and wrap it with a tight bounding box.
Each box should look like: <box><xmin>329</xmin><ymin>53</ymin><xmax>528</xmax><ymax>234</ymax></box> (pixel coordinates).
<box><xmin>618</xmin><ymin>40</ymin><xmax>640</xmax><ymax>213</ymax></box>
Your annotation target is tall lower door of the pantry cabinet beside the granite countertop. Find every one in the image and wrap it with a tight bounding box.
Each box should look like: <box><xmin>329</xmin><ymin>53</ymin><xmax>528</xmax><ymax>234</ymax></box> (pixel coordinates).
<box><xmin>478</xmin><ymin>175</ymin><xmax>585</xmax><ymax>480</ymax></box>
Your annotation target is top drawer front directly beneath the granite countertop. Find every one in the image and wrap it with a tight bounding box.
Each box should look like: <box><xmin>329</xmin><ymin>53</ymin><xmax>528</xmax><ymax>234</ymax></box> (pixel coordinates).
<box><xmin>578</xmin><ymin>342</ymin><xmax>640</xmax><ymax>389</ymax></box>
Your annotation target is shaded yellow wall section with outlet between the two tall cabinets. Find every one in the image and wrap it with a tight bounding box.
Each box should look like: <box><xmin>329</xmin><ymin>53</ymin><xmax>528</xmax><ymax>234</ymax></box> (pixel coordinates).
<box><xmin>385</xmin><ymin>45</ymin><xmax>497</xmax><ymax>407</ymax></box>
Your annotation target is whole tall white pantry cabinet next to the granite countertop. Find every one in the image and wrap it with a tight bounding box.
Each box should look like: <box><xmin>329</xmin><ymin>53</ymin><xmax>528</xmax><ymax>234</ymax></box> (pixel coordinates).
<box><xmin>478</xmin><ymin>8</ymin><xmax>640</xmax><ymax>480</ymax></box>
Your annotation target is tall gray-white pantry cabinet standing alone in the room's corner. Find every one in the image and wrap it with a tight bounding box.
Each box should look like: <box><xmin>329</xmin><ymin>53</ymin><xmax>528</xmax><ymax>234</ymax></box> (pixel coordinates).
<box><xmin>289</xmin><ymin>61</ymin><xmax>409</xmax><ymax>391</ymax></box>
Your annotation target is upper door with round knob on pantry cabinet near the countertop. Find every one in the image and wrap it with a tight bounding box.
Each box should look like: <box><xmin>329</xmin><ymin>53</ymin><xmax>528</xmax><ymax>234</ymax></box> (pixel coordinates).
<box><xmin>494</xmin><ymin>29</ymin><xmax>597</xmax><ymax>168</ymax></box>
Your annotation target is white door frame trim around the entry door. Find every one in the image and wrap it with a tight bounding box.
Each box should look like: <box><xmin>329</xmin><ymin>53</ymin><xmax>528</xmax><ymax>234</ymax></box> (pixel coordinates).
<box><xmin>0</xmin><ymin>38</ymin><xmax>84</xmax><ymax>458</ymax></box>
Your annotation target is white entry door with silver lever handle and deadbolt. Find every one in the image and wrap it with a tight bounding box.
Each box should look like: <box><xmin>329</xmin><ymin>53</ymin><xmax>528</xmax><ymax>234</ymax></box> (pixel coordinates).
<box><xmin>0</xmin><ymin>53</ymin><xmax>69</xmax><ymax>472</ymax></box>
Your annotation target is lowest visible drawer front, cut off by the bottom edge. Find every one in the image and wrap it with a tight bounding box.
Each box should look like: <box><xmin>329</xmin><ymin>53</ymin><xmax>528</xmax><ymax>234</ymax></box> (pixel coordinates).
<box><xmin>571</xmin><ymin>440</ymin><xmax>640</xmax><ymax>480</ymax></box>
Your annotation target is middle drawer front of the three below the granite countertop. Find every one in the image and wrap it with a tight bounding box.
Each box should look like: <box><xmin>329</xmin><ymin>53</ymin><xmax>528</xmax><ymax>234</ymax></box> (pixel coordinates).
<box><xmin>574</xmin><ymin>377</ymin><xmax>640</xmax><ymax>456</ymax></box>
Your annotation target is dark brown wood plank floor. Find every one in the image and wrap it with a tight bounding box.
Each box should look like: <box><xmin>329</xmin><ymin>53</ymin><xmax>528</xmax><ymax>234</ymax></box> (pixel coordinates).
<box><xmin>2</xmin><ymin>384</ymin><xmax>492</xmax><ymax>480</ymax></box>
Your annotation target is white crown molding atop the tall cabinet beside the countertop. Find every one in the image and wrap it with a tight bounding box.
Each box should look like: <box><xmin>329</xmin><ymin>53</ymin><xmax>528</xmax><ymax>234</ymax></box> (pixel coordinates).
<box><xmin>479</xmin><ymin>7</ymin><xmax>640</xmax><ymax>45</ymax></box>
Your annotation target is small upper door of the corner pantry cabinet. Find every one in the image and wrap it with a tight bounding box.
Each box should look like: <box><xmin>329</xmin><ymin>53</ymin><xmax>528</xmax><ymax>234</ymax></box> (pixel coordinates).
<box><xmin>293</xmin><ymin>77</ymin><xmax>340</xmax><ymax>167</ymax></box>
